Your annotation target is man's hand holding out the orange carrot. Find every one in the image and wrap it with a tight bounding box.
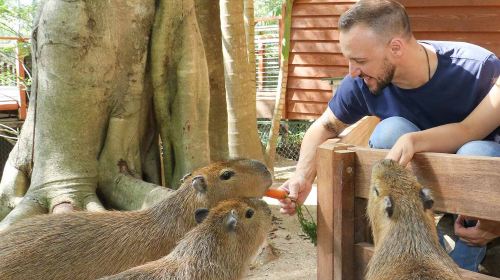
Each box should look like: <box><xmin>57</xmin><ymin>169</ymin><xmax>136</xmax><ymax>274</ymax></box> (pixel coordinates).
<box><xmin>280</xmin><ymin>175</ymin><xmax>312</xmax><ymax>215</ymax></box>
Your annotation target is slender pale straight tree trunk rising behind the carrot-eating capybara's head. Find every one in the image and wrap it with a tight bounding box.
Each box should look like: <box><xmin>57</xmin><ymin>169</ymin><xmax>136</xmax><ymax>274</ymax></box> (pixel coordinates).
<box><xmin>220</xmin><ymin>0</ymin><xmax>264</xmax><ymax>160</ymax></box>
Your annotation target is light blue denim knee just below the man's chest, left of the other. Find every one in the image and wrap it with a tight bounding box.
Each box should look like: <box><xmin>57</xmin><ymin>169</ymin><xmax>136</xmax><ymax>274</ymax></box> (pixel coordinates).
<box><xmin>369</xmin><ymin>117</ymin><xmax>420</xmax><ymax>149</ymax></box>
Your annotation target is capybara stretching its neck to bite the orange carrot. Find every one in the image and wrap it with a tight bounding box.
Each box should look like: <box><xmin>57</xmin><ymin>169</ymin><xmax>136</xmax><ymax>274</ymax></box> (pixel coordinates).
<box><xmin>0</xmin><ymin>159</ymin><xmax>272</xmax><ymax>280</ymax></box>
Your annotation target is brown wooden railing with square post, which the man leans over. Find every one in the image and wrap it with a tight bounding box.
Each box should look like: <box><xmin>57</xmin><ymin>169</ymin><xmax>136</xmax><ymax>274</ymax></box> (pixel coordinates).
<box><xmin>316</xmin><ymin>140</ymin><xmax>500</xmax><ymax>280</ymax></box>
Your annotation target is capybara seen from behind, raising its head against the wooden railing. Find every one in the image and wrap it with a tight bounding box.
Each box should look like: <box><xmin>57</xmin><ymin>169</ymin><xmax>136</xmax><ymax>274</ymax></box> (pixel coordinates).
<box><xmin>366</xmin><ymin>159</ymin><xmax>461</xmax><ymax>280</ymax></box>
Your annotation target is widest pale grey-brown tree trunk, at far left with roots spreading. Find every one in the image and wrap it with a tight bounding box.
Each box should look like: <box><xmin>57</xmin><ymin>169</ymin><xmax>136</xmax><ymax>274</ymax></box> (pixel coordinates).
<box><xmin>0</xmin><ymin>0</ymin><xmax>154</xmax><ymax>228</ymax></box>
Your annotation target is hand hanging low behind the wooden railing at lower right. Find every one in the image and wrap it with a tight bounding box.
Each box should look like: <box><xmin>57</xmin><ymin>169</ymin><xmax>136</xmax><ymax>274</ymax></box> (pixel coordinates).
<box><xmin>455</xmin><ymin>215</ymin><xmax>500</xmax><ymax>246</ymax></box>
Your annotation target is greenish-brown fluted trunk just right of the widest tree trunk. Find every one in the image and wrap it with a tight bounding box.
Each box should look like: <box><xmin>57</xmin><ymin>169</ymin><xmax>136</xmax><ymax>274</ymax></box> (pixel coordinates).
<box><xmin>151</xmin><ymin>0</ymin><xmax>210</xmax><ymax>187</ymax></box>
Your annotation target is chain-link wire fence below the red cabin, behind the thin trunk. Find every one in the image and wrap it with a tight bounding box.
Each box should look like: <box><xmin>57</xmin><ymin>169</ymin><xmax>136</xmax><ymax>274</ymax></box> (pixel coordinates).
<box><xmin>257</xmin><ymin>119</ymin><xmax>312</xmax><ymax>161</ymax></box>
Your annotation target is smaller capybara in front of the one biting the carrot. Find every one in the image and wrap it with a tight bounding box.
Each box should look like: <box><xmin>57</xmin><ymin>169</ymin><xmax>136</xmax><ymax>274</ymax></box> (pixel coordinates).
<box><xmin>99</xmin><ymin>199</ymin><xmax>271</xmax><ymax>280</ymax></box>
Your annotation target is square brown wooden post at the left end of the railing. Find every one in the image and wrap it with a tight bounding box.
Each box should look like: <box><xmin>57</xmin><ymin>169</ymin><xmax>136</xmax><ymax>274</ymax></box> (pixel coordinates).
<box><xmin>317</xmin><ymin>141</ymin><xmax>355</xmax><ymax>280</ymax></box>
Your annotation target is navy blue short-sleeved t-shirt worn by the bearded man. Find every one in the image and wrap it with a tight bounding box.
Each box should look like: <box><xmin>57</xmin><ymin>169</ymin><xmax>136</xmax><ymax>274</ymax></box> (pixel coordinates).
<box><xmin>328</xmin><ymin>41</ymin><xmax>500</xmax><ymax>139</ymax></box>
